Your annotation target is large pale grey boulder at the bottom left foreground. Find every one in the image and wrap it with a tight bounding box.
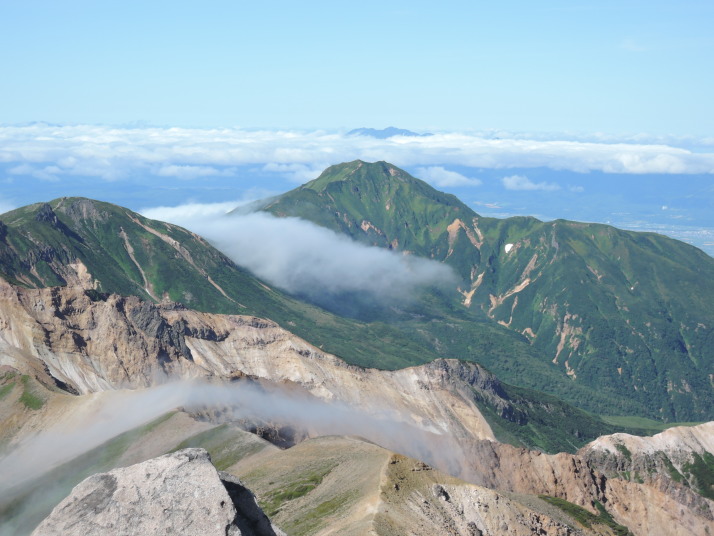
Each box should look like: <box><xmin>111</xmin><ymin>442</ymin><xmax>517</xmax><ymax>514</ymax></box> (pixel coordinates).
<box><xmin>32</xmin><ymin>449</ymin><xmax>284</xmax><ymax>536</ymax></box>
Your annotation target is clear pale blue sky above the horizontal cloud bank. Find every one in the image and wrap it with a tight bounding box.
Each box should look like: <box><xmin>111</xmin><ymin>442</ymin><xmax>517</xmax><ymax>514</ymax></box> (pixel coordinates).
<box><xmin>0</xmin><ymin>0</ymin><xmax>714</xmax><ymax>136</ymax></box>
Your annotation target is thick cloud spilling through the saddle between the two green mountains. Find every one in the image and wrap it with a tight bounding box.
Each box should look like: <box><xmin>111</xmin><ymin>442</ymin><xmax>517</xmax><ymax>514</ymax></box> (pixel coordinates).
<box><xmin>142</xmin><ymin>207</ymin><xmax>456</xmax><ymax>312</ymax></box>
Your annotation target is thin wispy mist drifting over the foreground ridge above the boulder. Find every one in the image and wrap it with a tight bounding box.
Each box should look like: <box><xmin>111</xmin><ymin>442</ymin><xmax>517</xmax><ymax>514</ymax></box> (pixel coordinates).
<box><xmin>0</xmin><ymin>381</ymin><xmax>466</xmax><ymax>500</ymax></box>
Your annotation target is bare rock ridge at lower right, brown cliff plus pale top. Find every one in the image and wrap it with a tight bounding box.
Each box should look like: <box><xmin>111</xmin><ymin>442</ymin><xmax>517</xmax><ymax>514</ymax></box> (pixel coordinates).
<box><xmin>462</xmin><ymin>423</ymin><xmax>714</xmax><ymax>536</ymax></box>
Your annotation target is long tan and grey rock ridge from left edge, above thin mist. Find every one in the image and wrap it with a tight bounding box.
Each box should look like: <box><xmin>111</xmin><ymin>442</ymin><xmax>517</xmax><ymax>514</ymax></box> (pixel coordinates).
<box><xmin>0</xmin><ymin>281</ymin><xmax>498</xmax><ymax>439</ymax></box>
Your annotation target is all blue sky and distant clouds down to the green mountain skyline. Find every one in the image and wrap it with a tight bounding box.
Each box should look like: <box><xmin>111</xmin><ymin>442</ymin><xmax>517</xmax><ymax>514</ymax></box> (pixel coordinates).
<box><xmin>0</xmin><ymin>0</ymin><xmax>714</xmax><ymax>254</ymax></box>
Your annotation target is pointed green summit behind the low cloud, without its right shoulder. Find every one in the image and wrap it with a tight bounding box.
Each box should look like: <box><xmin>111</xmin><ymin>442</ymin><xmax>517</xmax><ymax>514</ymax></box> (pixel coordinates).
<box><xmin>263</xmin><ymin>160</ymin><xmax>479</xmax><ymax>260</ymax></box>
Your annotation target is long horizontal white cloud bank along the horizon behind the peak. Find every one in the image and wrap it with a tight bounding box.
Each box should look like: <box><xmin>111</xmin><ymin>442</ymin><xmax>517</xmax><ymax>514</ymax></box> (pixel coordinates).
<box><xmin>0</xmin><ymin>124</ymin><xmax>714</xmax><ymax>185</ymax></box>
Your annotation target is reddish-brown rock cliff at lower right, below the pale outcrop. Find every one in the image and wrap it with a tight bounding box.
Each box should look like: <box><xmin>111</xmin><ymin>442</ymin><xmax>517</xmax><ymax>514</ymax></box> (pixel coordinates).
<box><xmin>456</xmin><ymin>436</ymin><xmax>714</xmax><ymax>536</ymax></box>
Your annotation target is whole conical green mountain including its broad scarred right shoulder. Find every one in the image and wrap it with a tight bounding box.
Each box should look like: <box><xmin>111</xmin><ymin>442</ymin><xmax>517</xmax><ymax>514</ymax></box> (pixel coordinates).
<box><xmin>264</xmin><ymin>161</ymin><xmax>714</xmax><ymax>419</ymax></box>
